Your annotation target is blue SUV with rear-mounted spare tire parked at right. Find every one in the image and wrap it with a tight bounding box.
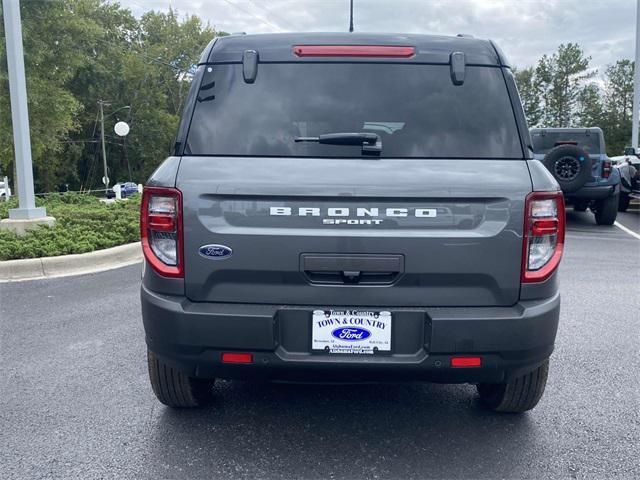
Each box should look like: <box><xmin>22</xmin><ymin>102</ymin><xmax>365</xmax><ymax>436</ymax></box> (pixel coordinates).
<box><xmin>530</xmin><ymin>127</ymin><xmax>620</xmax><ymax>225</ymax></box>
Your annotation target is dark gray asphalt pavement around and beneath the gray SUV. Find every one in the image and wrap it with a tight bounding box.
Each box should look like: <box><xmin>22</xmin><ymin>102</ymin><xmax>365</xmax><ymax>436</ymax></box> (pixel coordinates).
<box><xmin>0</xmin><ymin>211</ymin><xmax>640</xmax><ymax>480</ymax></box>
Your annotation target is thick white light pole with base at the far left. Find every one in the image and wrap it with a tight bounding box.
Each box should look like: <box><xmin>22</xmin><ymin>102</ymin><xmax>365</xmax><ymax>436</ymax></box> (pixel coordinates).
<box><xmin>2</xmin><ymin>0</ymin><xmax>47</xmax><ymax>220</ymax></box>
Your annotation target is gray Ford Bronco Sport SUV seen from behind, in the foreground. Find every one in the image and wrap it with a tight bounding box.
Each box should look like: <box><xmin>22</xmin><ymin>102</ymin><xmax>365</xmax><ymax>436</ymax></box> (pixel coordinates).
<box><xmin>141</xmin><ymin>33</ymin><xmax>565</xmax><ymax>412</ymax></box>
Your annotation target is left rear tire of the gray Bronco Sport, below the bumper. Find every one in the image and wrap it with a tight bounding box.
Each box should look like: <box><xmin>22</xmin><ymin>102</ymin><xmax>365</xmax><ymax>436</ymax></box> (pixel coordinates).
<box><xmin>147</xmin><ymin>350</ymin><xmax>214</xmax><ymax>408</ymax></box>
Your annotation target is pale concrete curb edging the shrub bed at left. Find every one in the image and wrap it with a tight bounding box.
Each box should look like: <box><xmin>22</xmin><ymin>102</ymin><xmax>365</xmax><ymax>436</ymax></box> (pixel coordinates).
<box><xmin>0</xmin><ymin>242</ymin><xmax>142</xmax><ymax>283</ymax></box>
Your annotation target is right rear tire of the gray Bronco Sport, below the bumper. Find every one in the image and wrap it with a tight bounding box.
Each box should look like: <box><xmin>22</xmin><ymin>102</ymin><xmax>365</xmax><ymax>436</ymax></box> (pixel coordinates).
<box><xmin>478</xmin><ymin>360</ymin><xmax>549</xmax><ymax>413</ymax></box>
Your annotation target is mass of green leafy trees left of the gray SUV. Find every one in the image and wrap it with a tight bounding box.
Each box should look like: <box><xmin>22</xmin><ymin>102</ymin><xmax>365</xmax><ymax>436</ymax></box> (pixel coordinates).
<box><xmin>0</xmin><ymin>0</ymin><xmax>223</xmax><ymax>192</ymax></box>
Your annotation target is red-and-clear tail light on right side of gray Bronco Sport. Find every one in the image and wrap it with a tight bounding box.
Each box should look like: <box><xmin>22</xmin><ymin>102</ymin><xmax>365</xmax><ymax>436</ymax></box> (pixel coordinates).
<box><xmin>522</xmin><ymin>192</ymin><xmax>565</xmax><ymax>283</ymax></box>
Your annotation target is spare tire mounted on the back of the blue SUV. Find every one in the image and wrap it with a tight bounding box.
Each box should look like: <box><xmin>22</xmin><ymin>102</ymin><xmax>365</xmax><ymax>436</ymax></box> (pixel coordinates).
<box><xmin>542</xmin><ymin>145</ymin><xmax>591</xmax><ymax>193</ymax></box>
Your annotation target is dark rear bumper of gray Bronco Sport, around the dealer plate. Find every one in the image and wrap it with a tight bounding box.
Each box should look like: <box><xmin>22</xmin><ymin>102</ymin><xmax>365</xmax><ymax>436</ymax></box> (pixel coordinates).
<box><xmin>141</xmin><ymin>286</ymin><xmax>560</xmax><ymax>383</ymax></box>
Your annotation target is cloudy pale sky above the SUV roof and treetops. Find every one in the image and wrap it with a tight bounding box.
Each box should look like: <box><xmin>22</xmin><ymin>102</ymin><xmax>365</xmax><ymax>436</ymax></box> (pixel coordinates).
<box><xmin>121</xmin><ymin>0</ymin><xmax>636</xmax><ymax>73</ymax></box>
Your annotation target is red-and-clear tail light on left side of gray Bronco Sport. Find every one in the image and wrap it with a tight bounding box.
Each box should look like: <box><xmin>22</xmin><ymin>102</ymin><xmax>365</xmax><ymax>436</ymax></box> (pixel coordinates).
<box><xmin>140</xmin><ymin>187</ymin><xmax>184</xmax><ymax>278</ymax></box>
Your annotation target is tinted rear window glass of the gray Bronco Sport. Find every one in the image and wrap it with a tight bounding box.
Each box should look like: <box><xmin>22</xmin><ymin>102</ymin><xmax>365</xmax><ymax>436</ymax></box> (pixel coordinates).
<box><xmin>185</xmin><ymin>62</ymin><xmax>522</xmax><ymax>159</ymax></box>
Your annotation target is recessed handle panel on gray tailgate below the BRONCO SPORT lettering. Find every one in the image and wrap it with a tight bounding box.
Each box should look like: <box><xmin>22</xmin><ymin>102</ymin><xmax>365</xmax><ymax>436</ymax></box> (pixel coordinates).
<box><xmin>300</xmin><ymin>254</ymin><xmax>404</xmax><ymax>285</ymax></box>
